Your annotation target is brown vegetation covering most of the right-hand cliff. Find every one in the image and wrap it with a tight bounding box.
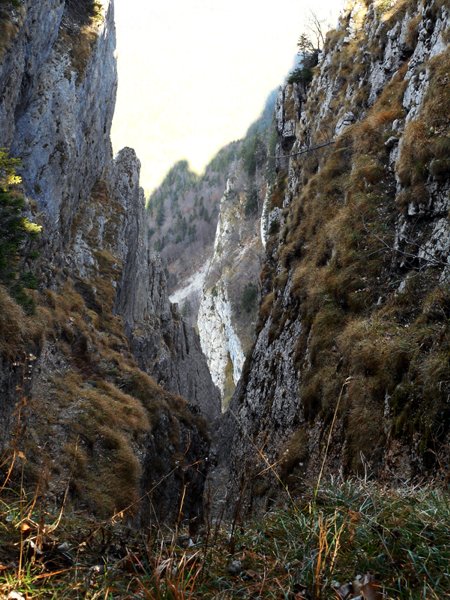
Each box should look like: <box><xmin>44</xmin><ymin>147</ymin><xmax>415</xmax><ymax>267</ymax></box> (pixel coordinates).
<box><xmin>253</xmin><ymin>2</ymin><xmax>450</xmax><ymax>486</ymax></box>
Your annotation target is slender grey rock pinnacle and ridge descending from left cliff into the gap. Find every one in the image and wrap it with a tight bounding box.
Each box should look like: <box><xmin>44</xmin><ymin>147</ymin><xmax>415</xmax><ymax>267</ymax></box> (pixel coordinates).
<box><xmin>107</xmin><ymin>149</ymin><xmax>220</xmax><ymax>421</ymax></box>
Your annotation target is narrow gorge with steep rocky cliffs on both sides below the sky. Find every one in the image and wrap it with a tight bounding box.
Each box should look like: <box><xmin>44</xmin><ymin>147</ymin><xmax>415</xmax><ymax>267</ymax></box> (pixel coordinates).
<box><xmin>0</xmin><ymin>0</ymin><xmax>450</xmax><ymax>600</ymax></box>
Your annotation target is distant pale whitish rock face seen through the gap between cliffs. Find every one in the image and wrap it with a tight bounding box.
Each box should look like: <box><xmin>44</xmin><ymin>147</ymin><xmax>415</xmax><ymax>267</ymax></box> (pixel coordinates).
<box><xmin>197</xmin><ymin>169</ymin><xmax>266</xmax><ymax>407</ymax></box>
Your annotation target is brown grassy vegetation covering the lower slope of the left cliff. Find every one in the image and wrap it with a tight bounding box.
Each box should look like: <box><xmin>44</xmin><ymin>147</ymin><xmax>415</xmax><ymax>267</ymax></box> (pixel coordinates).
<box><xmin>0</xmin><ymin>179</ymin><xmax>208</xmax><ymax>517</ymax></box>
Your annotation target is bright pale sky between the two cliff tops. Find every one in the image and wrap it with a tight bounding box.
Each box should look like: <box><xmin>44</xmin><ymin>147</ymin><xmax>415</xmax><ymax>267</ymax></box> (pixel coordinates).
<box><xmin>113</xmin><ymin>0</ymin><xmax>343</xmax><ymax>192</ymax></box>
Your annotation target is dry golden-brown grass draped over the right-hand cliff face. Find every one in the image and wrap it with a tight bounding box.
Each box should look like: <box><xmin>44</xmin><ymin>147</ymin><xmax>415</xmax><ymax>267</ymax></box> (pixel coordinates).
<box><xmin>263</xmin><ymin>2</ymin><xmax>450</xmax><ymax>478</ymax></box>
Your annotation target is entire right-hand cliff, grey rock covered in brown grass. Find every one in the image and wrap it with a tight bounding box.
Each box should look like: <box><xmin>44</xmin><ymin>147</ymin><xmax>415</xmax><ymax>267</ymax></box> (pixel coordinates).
<box><xmin>213</xmin><ymin>0</ymin><xmax>450</xmax><ymax>507</ymax></box>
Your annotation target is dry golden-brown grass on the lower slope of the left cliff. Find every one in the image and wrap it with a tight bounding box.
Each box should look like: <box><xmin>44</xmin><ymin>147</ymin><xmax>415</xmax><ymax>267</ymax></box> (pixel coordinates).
<box><xmin>0</xmin><ymin>179</ymin><xmax>207</xmax><ymax>516</ymax></box>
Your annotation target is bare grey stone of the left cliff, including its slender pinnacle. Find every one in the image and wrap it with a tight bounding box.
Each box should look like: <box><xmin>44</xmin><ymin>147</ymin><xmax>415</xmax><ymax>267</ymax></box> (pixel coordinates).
<box><xmin>0</xmin><ymin>0</ymin><xmax>218</xmax><ymax>417</ymax></box>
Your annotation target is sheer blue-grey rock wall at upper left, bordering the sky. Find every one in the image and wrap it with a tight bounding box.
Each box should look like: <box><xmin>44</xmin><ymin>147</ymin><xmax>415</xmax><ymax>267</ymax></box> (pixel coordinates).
<box><xmin>0</xmin><ymin>1</ymin><xmax>117</xmax><ymax>250</ymax></box>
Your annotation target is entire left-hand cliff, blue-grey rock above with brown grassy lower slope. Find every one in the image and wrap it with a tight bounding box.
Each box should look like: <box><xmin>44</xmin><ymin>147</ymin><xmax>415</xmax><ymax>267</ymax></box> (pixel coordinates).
<box><xmin>0</xmin><ymin>0</ymin><xmax>219</xmax><ymax>517</ymax></box>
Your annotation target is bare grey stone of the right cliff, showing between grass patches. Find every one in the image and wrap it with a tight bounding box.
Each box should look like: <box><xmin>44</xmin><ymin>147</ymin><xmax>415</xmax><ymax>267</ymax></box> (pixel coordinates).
<box><xmin>210</xmin><ymin>0</ymin><xmax>450</xmax><ymax>515</ymax></box>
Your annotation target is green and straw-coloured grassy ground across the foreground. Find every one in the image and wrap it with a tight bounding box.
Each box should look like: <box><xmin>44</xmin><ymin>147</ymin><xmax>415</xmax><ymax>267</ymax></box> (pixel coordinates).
<box><xmin>0</xmin><ymin>480</ymin><xmax>450</xmax><ymax>600</ymax></box>
